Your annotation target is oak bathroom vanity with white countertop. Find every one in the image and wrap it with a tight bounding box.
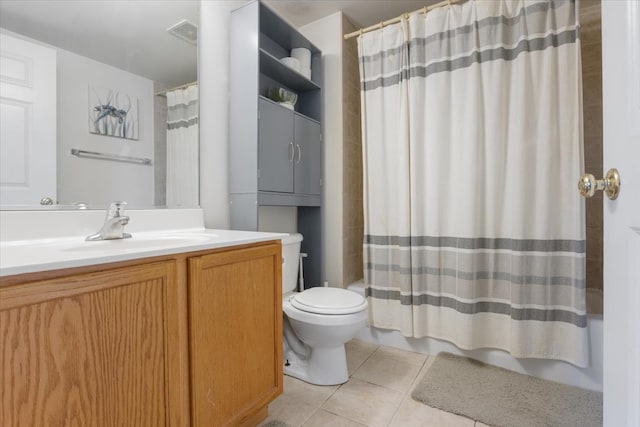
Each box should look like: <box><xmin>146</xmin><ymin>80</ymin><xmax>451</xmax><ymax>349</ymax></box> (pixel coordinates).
<box><xmin>0</xmin><ymin>211</ymin><xmax>282</xmax><ymax>426</ymax></box>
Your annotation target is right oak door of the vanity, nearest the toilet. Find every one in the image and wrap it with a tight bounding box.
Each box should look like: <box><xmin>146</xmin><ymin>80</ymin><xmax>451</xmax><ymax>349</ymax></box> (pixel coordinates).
<box><xmin>189</xmin><ymin>243</ymin><xmax>282</xmax><ymax>426</ymax></box>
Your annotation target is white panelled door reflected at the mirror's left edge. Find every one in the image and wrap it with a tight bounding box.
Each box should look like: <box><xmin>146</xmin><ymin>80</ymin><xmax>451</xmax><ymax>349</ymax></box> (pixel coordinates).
<box><xmin>0</xmin><ymin>34</ymin><xmax>56</xmax><ymax>206</ymax></box>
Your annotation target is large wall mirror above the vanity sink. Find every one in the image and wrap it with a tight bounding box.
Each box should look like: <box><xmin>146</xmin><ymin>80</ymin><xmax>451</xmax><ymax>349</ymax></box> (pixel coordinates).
<box><xmin>0</xmin><ymin>0</ymin><xmax>200</xmax><ymax>209</ymax></box>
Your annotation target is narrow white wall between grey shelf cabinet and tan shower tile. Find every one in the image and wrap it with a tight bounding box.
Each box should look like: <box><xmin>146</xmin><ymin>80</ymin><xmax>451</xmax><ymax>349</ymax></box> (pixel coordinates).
<box><xmin>299</xmin><ymin>12</ymin><xmax>345</xmax><ymax>287</ymax></box>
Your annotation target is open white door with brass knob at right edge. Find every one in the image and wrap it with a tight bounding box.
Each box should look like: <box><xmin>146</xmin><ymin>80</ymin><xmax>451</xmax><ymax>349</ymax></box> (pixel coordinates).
<box><xmin>602</xmin><ymin>0</ymin><xmax>640</xmax><ymax>427</ymax></box>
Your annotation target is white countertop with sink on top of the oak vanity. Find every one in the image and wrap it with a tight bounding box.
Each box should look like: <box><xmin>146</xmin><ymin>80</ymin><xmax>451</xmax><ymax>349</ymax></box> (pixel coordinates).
<box><xmin>0</xmin><ymin>210</ymin><xmax>286</xmax><ymax>277</ymax></box>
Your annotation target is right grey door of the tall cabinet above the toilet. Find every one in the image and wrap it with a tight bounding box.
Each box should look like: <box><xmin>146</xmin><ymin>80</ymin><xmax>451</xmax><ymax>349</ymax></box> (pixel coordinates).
<box><xmin>294</xmin><ymin>114</ymin><xmax>322</xmax><ymax>195</ymax></box>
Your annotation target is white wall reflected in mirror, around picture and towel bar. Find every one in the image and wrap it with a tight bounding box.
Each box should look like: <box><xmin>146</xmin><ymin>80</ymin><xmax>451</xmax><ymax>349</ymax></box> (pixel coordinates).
<box><xmin>57</xmin><ymin>49</ymin><xmax>154</xmax><ymax>207</ymax></box>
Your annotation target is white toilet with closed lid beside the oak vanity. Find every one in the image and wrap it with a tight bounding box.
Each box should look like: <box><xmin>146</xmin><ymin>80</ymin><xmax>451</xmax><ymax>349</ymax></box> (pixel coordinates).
<box><xmin>282</xmin><ymin>234</ymin><xmax>368</xmax><ymax>385</ymax></box>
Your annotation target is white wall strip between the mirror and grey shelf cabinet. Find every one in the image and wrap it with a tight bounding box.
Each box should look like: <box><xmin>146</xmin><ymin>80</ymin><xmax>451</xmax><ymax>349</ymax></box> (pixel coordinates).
<box><xmin>198</xmin><ymin>0</ymin><xmax>245</xmax><ymax>229</ymax></box>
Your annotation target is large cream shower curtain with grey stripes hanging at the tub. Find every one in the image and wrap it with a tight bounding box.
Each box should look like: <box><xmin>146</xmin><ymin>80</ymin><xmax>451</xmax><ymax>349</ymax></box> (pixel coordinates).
<box><xmin>358</xmin><ymin>0</ymin><xmax>589</xmax><ymax>367</ymax></box>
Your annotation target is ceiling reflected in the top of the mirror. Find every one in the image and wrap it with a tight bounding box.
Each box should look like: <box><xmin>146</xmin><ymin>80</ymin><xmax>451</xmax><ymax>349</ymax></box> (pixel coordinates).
<box><xmin>0</xmin><ymin>0</ymin><xmax>200</xmax><ymax>86</ymax></box>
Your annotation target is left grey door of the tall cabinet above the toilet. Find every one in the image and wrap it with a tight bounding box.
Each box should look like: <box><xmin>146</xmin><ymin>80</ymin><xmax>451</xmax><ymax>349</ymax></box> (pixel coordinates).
<box><xmin>258</xmin><ymin>99</ymin><xmax>294</xmax><ymax>193</ymax></box>
